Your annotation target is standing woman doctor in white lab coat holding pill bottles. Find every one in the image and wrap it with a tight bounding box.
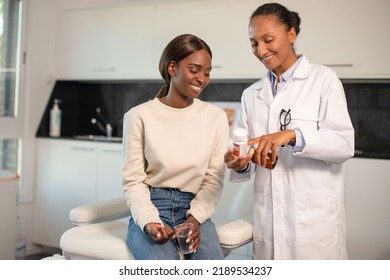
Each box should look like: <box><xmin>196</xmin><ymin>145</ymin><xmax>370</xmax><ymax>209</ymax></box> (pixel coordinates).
<box><xmin>224</xmin><ymin>3</ymin><xmax>354</xmax><ymax>259</ymax></box>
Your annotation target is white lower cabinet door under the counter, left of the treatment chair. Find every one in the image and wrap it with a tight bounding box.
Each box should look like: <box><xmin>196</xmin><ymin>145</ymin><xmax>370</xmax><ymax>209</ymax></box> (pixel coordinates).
<box><xmin>33</xmin><ymin>139</ymin><xmax>98</xmax><ymax>247</ymax></box>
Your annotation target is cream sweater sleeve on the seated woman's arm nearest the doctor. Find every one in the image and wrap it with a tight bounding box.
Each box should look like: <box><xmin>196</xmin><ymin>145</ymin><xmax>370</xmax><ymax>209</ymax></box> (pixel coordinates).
<box><xmin>188</xmin><ymin>111</ymin><xmax>229</xmax><ymax>223</ymax></box>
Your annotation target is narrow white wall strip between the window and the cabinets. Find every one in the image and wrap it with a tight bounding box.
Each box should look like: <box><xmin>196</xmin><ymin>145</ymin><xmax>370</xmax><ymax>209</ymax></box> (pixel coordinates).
<box><xmin>19</xmin><ymin>0</ymin><xmax>57</xmax><ymax>253</ymax></box>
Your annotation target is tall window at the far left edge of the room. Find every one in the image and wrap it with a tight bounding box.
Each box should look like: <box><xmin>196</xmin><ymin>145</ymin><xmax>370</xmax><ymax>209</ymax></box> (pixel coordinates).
<box><xmin>0</xmin><ymin>0</ymin><xmax>23</xmax><ymax>174</ymax></box>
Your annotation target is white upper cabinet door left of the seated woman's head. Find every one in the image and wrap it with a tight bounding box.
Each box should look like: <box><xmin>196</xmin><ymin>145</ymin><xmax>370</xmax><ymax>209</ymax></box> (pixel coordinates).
<box><xmin>57</xmin><ymin>5</ymin><xmax>158</xmax><ymax>80</ymax></box>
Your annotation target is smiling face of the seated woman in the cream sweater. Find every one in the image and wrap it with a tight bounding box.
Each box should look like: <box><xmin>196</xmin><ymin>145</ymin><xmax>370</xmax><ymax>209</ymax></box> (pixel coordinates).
<box><xmin>168</xmin><ymin>50</ymin><xmax>211</xmax><ymax>104</ymax></box>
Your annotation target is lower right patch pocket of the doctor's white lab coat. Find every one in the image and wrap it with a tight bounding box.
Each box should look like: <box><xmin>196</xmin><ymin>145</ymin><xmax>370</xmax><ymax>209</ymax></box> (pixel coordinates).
<box><xmin>295</xmin><ymin>190</ymin><xmax>339</xmax><ymax>241</ymax></box>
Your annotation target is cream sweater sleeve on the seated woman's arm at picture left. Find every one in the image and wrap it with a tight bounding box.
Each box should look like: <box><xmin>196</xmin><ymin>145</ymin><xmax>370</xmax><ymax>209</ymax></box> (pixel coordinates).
<box><xmin>122</xmin><ymin>111</ymin><xmax>162</xmax><ymax>230</ymax></box>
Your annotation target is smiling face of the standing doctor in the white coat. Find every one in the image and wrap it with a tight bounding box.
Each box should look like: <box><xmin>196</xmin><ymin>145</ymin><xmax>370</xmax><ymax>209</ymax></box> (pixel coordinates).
<box><xmin>249</xmin><ymin>15</ymin><xmax>297</xmax><ymax>76</ymax></box>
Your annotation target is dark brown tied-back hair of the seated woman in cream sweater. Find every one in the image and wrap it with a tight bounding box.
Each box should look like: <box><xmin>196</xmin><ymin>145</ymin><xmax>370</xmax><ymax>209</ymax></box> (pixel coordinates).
<box><xmin>157</xmin><ymin>34</ymin><xmax>212</xmax><ymax>97</ymax></box>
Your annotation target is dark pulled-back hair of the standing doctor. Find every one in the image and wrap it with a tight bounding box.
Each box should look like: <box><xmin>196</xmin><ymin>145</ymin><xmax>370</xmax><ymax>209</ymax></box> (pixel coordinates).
<box><xmin>250</xmin><ymin>3</ymin><xmax>301</xmax><ymax>35</ymax></box>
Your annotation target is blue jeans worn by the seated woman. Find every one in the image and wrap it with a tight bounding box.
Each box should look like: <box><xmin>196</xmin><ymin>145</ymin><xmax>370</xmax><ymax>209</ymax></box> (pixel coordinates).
<box><xmin>127</xmin><ymin>188</ymin><xmax>224</xmax><ymax>260</ymax></box>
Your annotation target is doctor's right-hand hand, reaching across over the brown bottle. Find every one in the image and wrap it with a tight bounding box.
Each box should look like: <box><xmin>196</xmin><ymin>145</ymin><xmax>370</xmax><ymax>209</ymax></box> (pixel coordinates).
<box><xmin>248</xmin><ymin>129</ymin><xmax>296</xmax><ymax>167</ymax></box>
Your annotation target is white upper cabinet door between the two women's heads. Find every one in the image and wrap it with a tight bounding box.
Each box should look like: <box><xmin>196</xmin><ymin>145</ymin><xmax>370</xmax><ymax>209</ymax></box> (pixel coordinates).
<box><xmin>154</xmin><ymin>0</ymin><xmax>266</xmax><ymax>79</ymax></box>
